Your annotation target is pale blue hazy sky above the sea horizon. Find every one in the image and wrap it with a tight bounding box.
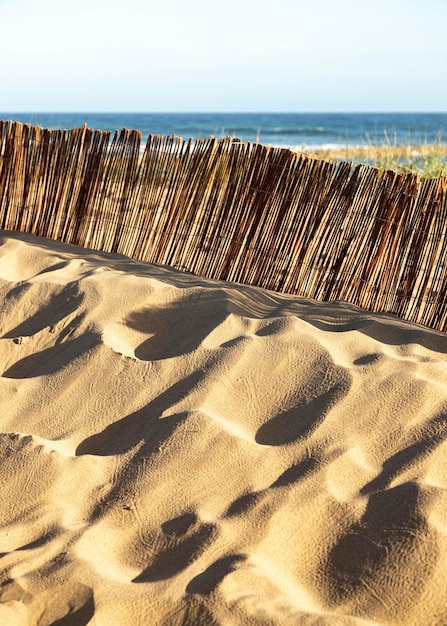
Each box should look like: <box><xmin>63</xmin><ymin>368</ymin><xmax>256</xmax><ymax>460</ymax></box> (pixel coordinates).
<box><xmin>0</xmin><ymin>0</ymin><xmax>447</xmax><ymax>112</ymax></box>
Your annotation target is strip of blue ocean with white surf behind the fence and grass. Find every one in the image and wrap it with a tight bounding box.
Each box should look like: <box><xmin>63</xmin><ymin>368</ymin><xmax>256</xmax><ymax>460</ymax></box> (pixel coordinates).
<box><xmin>0</xmin><ymin>112</ymin><xmax>447</xmax><ymax>149</ymax></box>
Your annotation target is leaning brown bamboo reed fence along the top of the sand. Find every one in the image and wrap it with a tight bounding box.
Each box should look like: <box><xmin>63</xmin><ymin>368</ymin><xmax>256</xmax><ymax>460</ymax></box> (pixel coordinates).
<box><xmin>0</xmin><ymin>121</ymin><xmax>447</xmax><ymax>331</ymax></box>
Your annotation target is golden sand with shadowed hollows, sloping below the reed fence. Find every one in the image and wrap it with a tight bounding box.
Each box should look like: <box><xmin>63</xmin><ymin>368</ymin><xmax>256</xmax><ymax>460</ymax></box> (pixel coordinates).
<box><xmin>0</xmin><ymin>231</ymin><xmax>447</xmax><ymax>626</ymax></box>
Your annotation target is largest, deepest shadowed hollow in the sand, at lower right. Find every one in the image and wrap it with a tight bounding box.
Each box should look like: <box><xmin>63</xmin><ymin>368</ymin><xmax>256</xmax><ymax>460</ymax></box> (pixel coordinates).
<box><xmin>318</xmin><ymin>482</ymin><xmax>438</xmax><ymax>623</ymax></box>
